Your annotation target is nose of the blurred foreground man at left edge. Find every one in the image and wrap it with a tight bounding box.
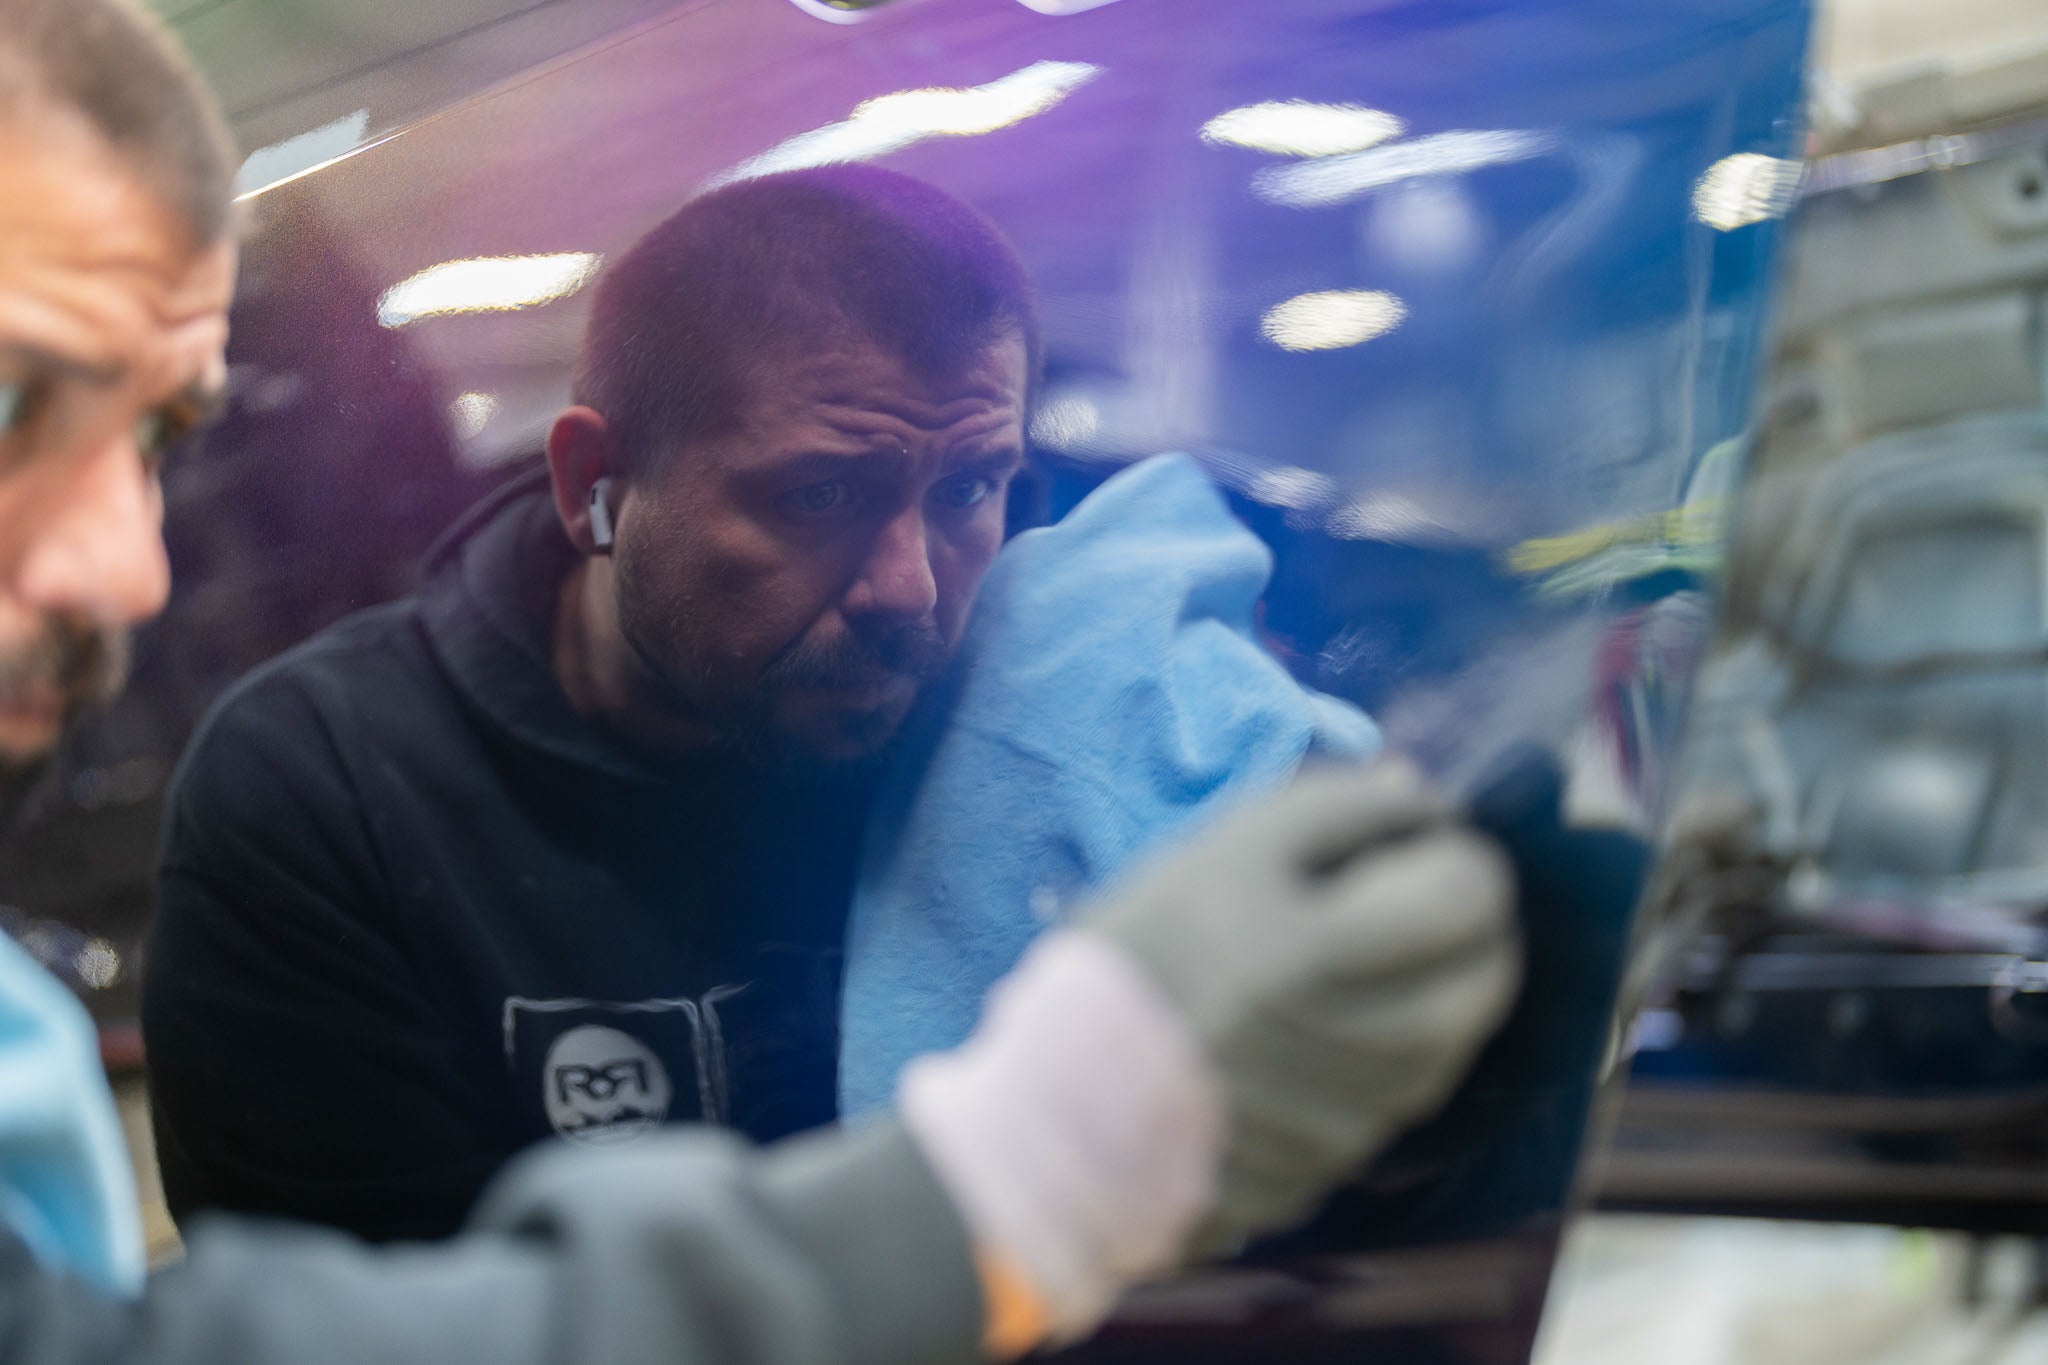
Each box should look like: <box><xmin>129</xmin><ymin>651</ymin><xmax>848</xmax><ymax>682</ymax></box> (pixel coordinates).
<box><xmin>16</xmin><ymin>438</ymin><xmax>170</xmax><ymax>624</ymax></box>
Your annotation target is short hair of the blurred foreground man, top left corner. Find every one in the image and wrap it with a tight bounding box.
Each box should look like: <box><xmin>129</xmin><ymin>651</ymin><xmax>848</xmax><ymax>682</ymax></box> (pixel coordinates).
<box><xmin>0</xmin><ymin>0</ymin><xmax>236</xmax><ymax>248</ymax></box>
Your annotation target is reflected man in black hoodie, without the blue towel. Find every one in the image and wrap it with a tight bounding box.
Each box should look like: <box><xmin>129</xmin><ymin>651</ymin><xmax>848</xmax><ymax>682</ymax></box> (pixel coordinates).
<box><xmin>143</xmin><ymin>168</ymin><xmax>1038</xmax><ymax>1236</ymax></box>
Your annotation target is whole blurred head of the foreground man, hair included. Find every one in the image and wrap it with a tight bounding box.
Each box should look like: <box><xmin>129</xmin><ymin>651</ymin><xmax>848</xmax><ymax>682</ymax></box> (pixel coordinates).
<box><xmin>0</xmin><ymin>0</ymin><xmax>236</xmax><ymax>786</ymax></box>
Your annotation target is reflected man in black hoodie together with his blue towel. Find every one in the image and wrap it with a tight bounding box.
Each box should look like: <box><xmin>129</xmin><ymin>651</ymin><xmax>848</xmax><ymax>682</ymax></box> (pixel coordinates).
<box><xmin>145</xmin><ymin>154</ymin><xmax>1376</xmax><ymax>1236</ymax></box>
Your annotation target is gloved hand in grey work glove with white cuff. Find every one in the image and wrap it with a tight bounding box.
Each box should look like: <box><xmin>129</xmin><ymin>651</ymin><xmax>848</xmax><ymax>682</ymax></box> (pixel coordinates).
<box><xmin>899</xmin><ymin>763</ymin><xmax>1520</xmax><ymax>1336</ymax></box>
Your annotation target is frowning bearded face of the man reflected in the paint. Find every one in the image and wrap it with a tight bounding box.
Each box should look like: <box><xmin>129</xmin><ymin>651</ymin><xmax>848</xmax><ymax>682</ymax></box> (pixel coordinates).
<box><xmin>614</xmin><ymin>340</ymin><xmax>1026</xmax><ymax>763</ymax></box>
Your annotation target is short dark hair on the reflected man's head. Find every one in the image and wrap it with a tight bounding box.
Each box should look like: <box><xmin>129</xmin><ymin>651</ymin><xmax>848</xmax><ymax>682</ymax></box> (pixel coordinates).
<box><xmin>573</xmin><ymin>166</ymin><xmax>1038</xmax><ymax>473</ymax></box>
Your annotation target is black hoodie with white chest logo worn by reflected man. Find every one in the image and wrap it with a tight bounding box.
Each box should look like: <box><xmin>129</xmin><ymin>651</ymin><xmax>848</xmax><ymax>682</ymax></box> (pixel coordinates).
<box><xmin>143</xmin><ymin>471</ymin><xmax>866</xmax><ymax>1238</ymax></box>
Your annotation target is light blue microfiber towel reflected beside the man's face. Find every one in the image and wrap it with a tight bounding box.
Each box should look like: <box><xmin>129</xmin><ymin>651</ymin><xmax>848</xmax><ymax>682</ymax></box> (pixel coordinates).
<box><xmin>840</xmin><ymin>454</ymin><xmax>1380</xmax><ymax>1115</ymax></box>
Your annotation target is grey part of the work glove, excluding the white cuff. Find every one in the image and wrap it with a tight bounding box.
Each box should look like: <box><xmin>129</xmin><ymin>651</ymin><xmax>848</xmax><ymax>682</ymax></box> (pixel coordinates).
<box><xmin>1081</xmin><ymin>761</ymin><xmax>1520</xmax><ymax>1254</ymax></box>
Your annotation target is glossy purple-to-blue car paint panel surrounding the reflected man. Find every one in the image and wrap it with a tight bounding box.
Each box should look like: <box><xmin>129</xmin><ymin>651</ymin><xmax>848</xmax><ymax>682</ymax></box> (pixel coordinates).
<box><xmin>0</xmin><ymin>0</ymin><xmax>1808</xmax><ymax>1361</ymax></box>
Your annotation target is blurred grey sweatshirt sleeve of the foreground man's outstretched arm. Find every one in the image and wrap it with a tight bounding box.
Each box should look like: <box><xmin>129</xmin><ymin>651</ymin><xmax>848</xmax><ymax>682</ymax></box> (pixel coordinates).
<box><xmin>0</xmin><ymin>1124</ymin><xmax>981</xmax><ymax>1365</ymax></box>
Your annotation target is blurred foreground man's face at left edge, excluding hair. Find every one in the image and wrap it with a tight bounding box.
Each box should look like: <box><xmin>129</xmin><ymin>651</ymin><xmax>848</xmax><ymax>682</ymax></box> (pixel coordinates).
<box><xmin>0</xmin><ymin>111</ymin><xmax>233</xmax><ymax>782</ymax></box>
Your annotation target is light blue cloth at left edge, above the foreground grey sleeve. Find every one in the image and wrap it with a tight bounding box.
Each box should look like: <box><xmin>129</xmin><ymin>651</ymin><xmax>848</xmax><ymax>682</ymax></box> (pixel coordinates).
<box><xmin>0</xmin><ymin>935</ymin><xmax>143</xmax><ymax>1293</ymax></box>
